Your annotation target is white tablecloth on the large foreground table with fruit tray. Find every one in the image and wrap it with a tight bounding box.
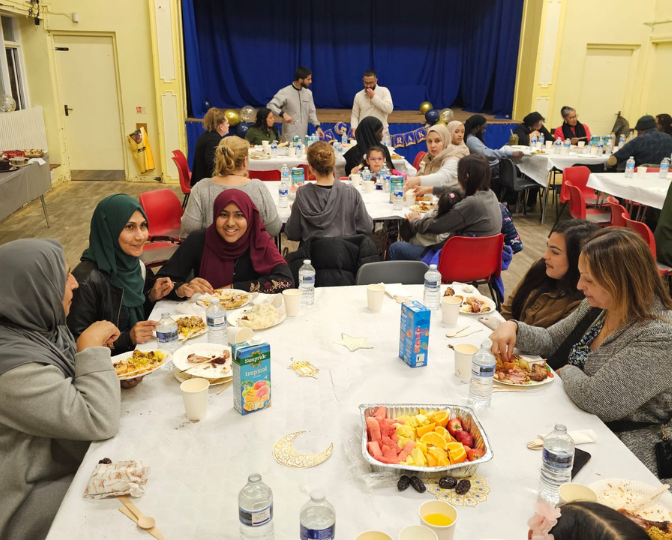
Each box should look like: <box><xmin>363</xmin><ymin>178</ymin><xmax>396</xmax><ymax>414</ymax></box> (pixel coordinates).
<box><xmin>48</xmin><ymin>286</ymin><xmax>659</xmax><ymax>540</ymax></box>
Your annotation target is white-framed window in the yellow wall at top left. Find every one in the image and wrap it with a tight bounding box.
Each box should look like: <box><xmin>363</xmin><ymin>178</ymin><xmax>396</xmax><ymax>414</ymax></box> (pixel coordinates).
<box><xmin>0</xmin><ymin>15</ymin><xmax>28</xmax><ymax>110</ymax></box>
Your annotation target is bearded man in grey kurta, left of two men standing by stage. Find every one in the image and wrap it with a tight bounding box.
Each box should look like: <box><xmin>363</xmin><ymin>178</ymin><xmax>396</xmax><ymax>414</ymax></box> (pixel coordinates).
<box><xmin>266</xmin><ymin>66</ymin><xmax>324</xmax><ymax>141</ymax></box>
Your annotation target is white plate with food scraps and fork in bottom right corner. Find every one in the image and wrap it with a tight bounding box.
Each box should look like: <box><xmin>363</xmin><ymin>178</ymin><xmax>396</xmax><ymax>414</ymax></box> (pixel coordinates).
<box><xmin>588</xmin><ymin>478</ymin><xmax>672</xmax><ymax>528</ymax></box>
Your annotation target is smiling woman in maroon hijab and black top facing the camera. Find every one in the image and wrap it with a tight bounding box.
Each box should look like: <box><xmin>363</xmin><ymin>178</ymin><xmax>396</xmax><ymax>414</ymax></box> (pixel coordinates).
<box><xmin>158</xmin><ymin>189</ymin><xmax>294</xmax><ymax>300</ymax></box>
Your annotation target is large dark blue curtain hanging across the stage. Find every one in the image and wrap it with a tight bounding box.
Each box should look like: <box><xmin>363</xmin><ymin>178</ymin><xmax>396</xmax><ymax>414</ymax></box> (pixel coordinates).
<box><xmin>182</xmin><ymin>0</ymin><xmax>523</xmax><ymax>118</ymax></box>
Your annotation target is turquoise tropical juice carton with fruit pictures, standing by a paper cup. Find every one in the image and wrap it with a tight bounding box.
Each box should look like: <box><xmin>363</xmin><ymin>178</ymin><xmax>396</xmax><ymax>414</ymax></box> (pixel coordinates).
<box><xmin>231</xmin><ymin>341</ymin><xmax>271</xmax><ymax>415</ymax></box>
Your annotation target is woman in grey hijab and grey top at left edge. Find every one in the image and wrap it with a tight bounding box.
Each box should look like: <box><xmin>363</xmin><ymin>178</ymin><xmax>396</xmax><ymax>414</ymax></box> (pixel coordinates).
<box><xmin>0</xmin><ymin>240</ymin><xmax>120</xmax><ymax>540</ymax></box>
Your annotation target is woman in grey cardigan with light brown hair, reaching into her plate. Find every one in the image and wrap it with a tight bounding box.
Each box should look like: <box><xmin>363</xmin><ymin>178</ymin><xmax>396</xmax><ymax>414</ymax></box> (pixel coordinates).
<box><xmin>491</xmin><ymin>227</ymin><xmax>672</xmax><ymax>477</ymax></box>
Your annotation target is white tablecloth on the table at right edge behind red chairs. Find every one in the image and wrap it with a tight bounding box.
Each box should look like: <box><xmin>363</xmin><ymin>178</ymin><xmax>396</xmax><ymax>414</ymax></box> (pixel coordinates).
<box><xmin>588</xmin><ymin>172</ymin><xmax>672</xmax><ymax>209</ymax></box>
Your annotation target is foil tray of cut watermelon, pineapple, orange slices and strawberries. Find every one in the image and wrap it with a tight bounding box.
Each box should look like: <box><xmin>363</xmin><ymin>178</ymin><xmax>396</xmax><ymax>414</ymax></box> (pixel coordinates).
<box><xmin>359</xmin><ymin>403</ymin><xmax>494</xmax><ymax>478</ymax></box>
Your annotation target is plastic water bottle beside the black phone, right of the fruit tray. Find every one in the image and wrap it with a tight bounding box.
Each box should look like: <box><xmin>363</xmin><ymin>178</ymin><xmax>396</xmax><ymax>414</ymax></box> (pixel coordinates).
<box><xmin>539</xmin><ymin>424</ymin><xmax>574</xmax><ymax>504</ymax></box>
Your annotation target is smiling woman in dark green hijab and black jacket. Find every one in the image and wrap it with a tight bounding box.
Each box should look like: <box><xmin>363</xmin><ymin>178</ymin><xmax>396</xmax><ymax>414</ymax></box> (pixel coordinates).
<box><xmin>68</xmin><ymin>194</ymin><xmax>173</xmax><ymax>354</ymax></box>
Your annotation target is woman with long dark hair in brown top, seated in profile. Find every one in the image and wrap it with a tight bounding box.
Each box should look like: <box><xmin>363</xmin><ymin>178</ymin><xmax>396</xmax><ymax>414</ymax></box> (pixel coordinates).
<box><xmin>501</xmin><ymin>219</ymin><xmax>599</xmax><ymax>328</ymax></box>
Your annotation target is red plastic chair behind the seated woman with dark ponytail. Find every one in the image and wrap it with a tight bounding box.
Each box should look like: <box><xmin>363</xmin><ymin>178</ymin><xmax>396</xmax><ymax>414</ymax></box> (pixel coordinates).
<box><xmin>439</xmin><ymin>233</ymin><xmax>504</xmax><ymax>310</ymax></box>
